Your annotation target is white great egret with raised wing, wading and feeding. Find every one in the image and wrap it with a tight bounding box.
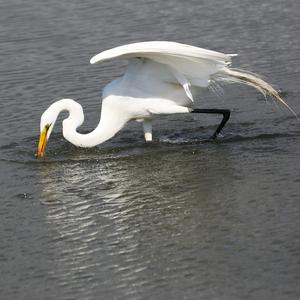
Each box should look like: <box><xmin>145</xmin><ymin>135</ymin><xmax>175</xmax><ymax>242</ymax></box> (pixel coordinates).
<box><xmin>37</xmin><ymin>41</ymin><xmax>294</xmax><ymax>157</ymax></box>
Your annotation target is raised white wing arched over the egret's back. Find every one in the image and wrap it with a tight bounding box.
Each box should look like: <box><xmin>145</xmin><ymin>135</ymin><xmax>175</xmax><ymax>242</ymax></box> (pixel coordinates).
<box><xmin>90</xmin><ymin>41</ymin><xmax>234</xmax><ymax>101</ymax></box>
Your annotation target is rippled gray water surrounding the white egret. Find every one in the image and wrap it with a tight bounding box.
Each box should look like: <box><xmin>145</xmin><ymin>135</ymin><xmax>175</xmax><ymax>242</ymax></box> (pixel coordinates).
<box><xmin>0</xmin><ymin>0</ymin><xmax>300</xmax><ymax>299</ymax></box>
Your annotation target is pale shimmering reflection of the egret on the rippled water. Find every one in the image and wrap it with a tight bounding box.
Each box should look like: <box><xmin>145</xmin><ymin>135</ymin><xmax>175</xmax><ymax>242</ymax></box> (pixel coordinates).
<box><xmin>40</xmin><ymin>145</ymin><xmax>236</xmax><ymax>297</ymax></box>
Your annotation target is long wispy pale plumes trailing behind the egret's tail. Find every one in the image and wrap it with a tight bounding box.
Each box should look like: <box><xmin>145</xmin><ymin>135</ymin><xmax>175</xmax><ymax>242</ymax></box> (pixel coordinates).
<box><xmin>217</xmin><ymin>68</ymin><xmax>299</xmax><ymax>119</ymax></box>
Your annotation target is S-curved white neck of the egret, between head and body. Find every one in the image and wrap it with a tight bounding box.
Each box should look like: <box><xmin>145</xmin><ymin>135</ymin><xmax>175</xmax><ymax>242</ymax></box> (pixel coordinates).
<box><xmin>49</xmin><ymin>99</ymin><xmax>126</xmax><ymax>147</ymax></box>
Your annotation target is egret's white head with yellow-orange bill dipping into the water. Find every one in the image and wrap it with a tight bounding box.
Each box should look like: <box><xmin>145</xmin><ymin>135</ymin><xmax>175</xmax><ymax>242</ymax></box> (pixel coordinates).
<box><xmin>37</xmin><ymin>106</ymin><xmax>58</xmax><ymax>158</ymax></box>
